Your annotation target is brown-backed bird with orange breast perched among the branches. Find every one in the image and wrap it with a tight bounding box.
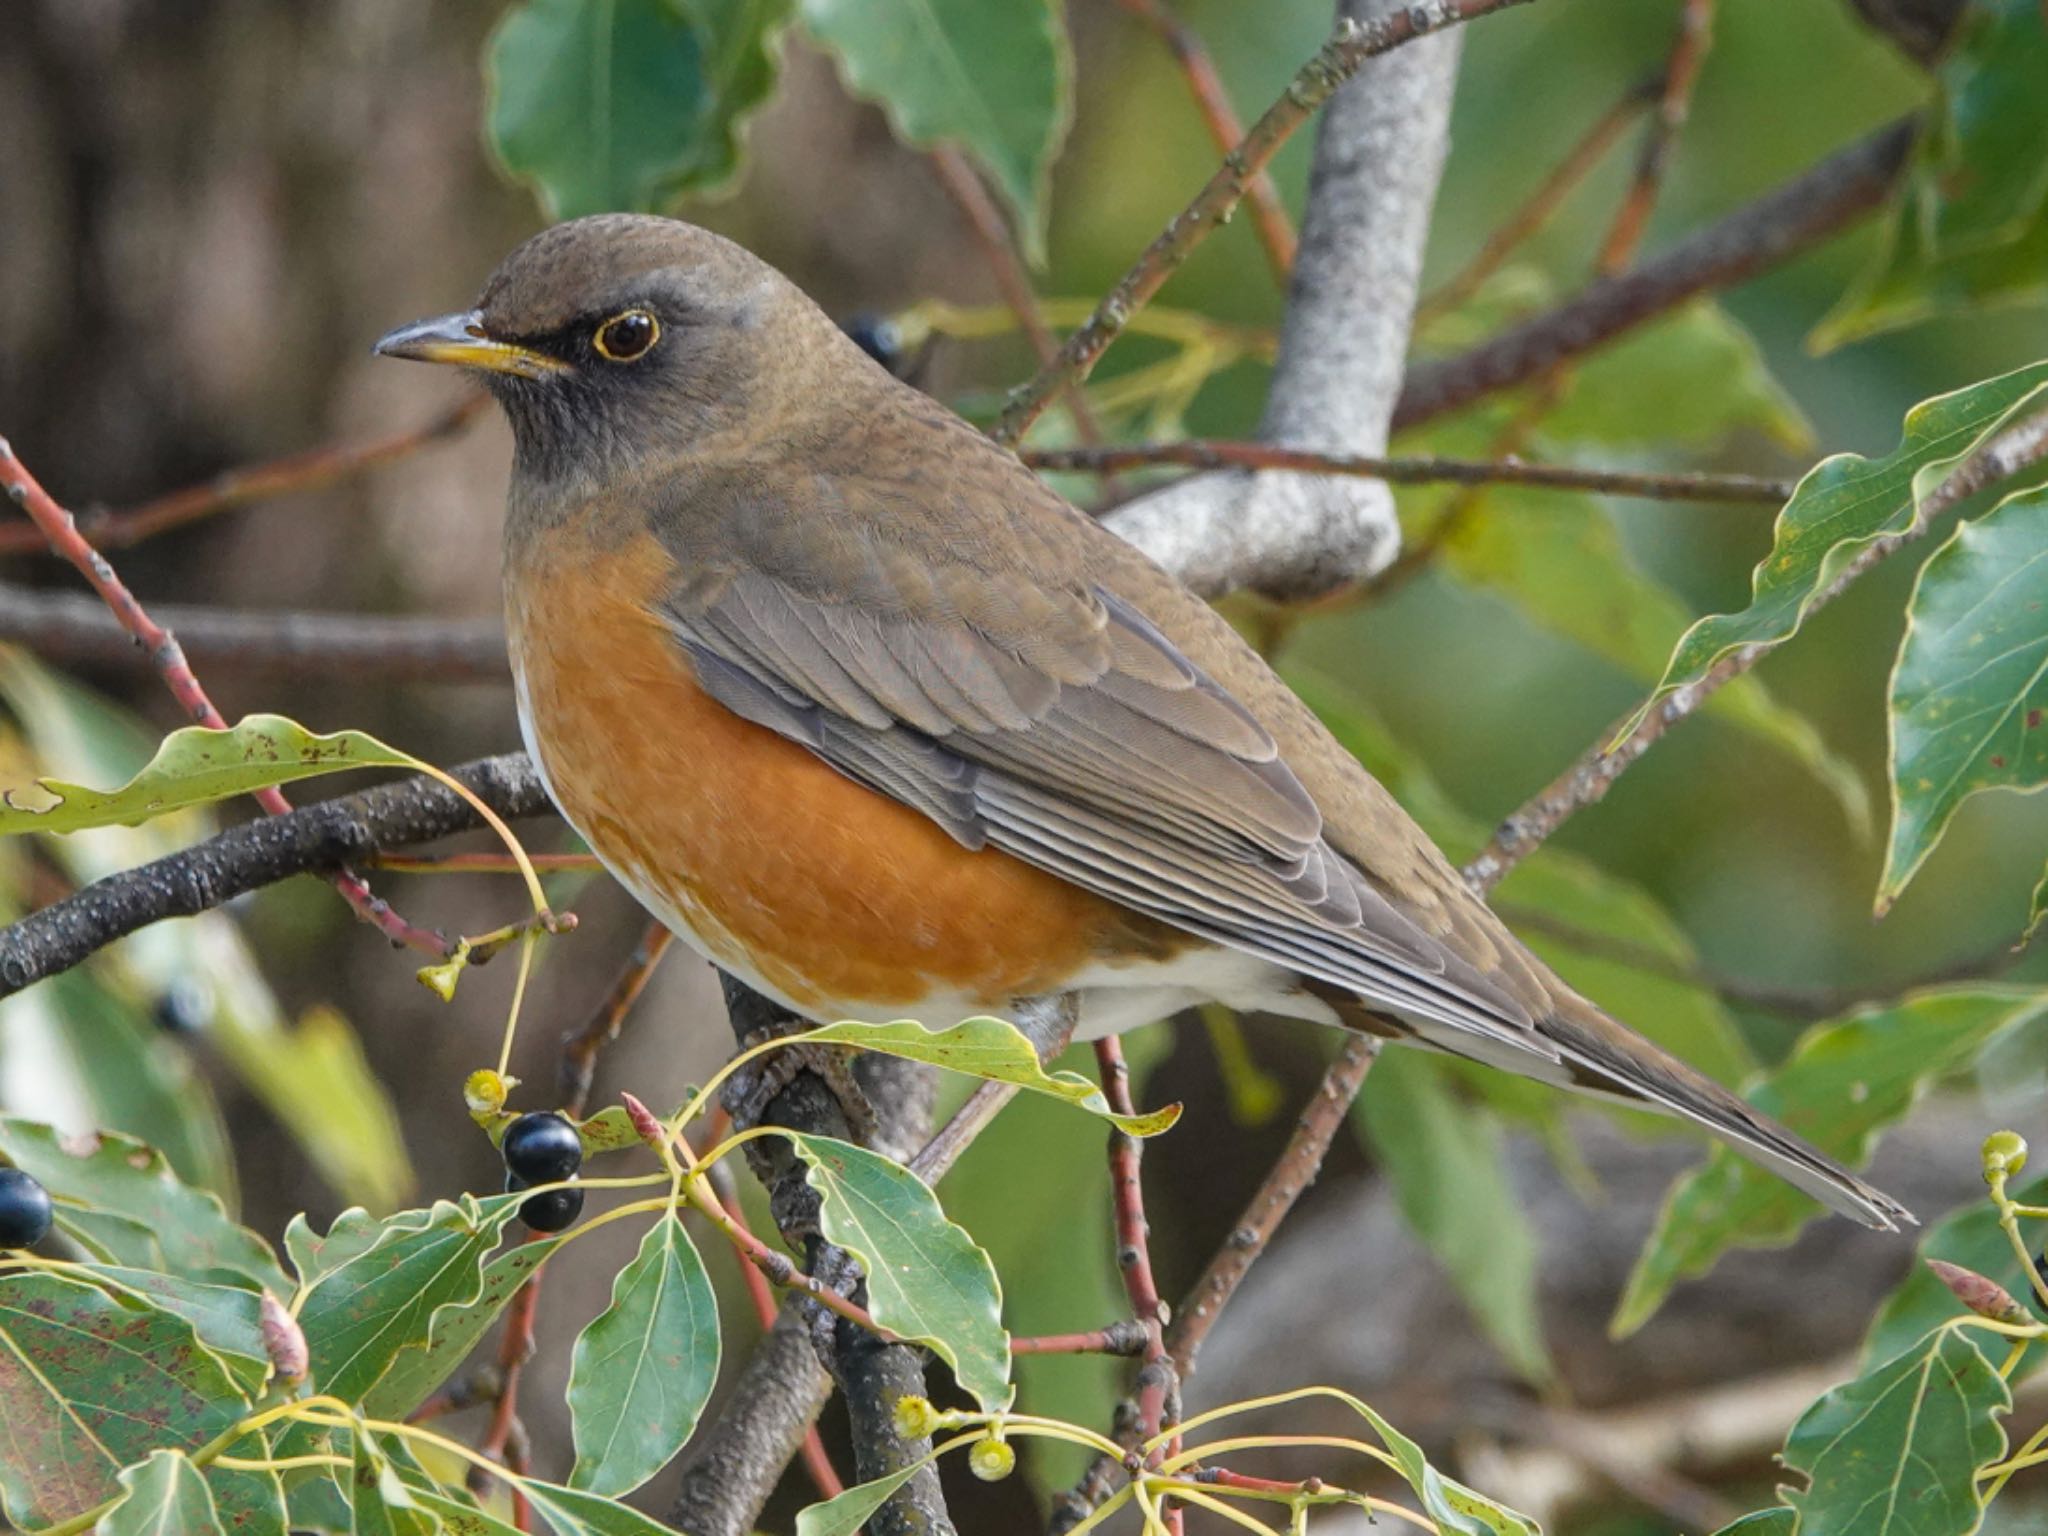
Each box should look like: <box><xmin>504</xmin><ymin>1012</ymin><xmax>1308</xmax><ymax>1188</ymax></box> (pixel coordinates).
<box><xmin>377</xmin><ymin>213</ymin><xmax>1911</xmax><ymax>1229</ymax></box>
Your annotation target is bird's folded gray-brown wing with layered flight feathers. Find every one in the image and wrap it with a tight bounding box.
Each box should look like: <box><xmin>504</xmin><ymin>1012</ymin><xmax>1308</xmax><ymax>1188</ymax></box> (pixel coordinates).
<box><xmin>664</xmin><ymin>549</ymin><xmax>1556</xmax><ymax>1061</ymax></box>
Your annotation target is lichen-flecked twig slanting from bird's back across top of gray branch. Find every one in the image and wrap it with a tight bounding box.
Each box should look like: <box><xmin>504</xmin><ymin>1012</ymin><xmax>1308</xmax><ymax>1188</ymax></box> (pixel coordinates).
<box><xmin>993</xmin><ymin>0</ymin><xmax>1528</xmax><ymax>442</ymax></box>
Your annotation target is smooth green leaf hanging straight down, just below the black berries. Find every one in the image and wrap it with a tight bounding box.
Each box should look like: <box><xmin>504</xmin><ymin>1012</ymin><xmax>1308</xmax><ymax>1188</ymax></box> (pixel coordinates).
<box><xmin>569</xmin><ymin>1210</ymin><xmax>719</xmax><ymax>1495</ymax></box>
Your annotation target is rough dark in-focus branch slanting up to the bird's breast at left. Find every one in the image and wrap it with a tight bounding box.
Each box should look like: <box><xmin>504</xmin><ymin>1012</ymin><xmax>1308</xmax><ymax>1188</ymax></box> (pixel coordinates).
<box><xmin>0</xmin><ymin>752</ymin><xmax>551</xmax><ymax>997</ymax></box>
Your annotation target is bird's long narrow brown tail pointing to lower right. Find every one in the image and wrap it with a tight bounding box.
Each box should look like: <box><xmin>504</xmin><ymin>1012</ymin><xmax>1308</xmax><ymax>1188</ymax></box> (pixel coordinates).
<box><xmin>1339</xmin><ymin>987</ymin><xmax>1917</xmax><ymax>1231</ymax></box>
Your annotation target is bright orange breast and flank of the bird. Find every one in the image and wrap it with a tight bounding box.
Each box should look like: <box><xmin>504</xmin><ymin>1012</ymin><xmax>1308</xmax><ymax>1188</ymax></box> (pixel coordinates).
<box><xmin>506</xmin><ymin>532</ymin><xmax>1157</xmax><ymax>1024</ymax></box>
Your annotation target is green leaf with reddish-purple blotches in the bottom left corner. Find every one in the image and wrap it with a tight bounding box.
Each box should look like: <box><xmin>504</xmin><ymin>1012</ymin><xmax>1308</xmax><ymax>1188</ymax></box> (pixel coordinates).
<box><xmin>0</xmin><ymin>1272</ymin><xmax>248</xmax><ymax>1528</ymax></box>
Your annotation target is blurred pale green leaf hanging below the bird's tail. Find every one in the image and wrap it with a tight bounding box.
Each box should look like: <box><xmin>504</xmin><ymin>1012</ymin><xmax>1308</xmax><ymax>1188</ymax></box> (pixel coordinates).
<box><xmin>1354</xmin><ymin>1051</ymin><xmax>1556</xmax><ymax>1382</ymax></box>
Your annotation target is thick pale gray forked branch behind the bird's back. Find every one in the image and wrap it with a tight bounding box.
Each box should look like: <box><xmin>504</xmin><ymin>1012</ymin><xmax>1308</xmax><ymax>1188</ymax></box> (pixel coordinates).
<box><xmin>1108</xmin><ymin>0</ymin><xmax>1460</xmax><ymax>598</ymax></box>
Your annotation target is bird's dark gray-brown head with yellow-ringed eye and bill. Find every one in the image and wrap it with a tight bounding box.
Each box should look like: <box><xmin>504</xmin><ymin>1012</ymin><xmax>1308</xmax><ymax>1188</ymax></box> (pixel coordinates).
<box><xmin>377</xmin><ymin>213</ymin><xmax>866</xmax><ymax>489</ymax></box>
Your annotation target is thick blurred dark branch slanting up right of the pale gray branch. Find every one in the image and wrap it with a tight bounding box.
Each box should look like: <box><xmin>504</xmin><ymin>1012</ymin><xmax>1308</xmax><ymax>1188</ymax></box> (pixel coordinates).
<box><xmin>1393</xmin><ymin>117</ymin><xmax>1915</xmax><ymax>430</ymax></box>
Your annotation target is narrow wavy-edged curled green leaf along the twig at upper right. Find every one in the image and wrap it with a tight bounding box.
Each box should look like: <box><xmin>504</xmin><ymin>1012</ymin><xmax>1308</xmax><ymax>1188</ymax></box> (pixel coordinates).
<box><xmin>1628</xmin><ymin>362</ymin><xmax>2048</xmax><ymax>729</ymax></box>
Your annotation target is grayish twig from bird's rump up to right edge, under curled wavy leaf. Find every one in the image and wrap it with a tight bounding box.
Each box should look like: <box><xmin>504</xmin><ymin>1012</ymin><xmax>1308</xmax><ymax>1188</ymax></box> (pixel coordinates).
<box><xmin>1464</xmin><ymin>412</ymin><xmax>2048</xmax><ymax>893</ymax></box>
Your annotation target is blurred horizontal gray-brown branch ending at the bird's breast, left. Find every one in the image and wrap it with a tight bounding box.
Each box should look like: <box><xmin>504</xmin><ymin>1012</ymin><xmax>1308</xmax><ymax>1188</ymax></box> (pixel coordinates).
<box><xmin>0</xmin><ymin>582</ymin><xmax>512</xmax><ymax>684</ymax></box>
